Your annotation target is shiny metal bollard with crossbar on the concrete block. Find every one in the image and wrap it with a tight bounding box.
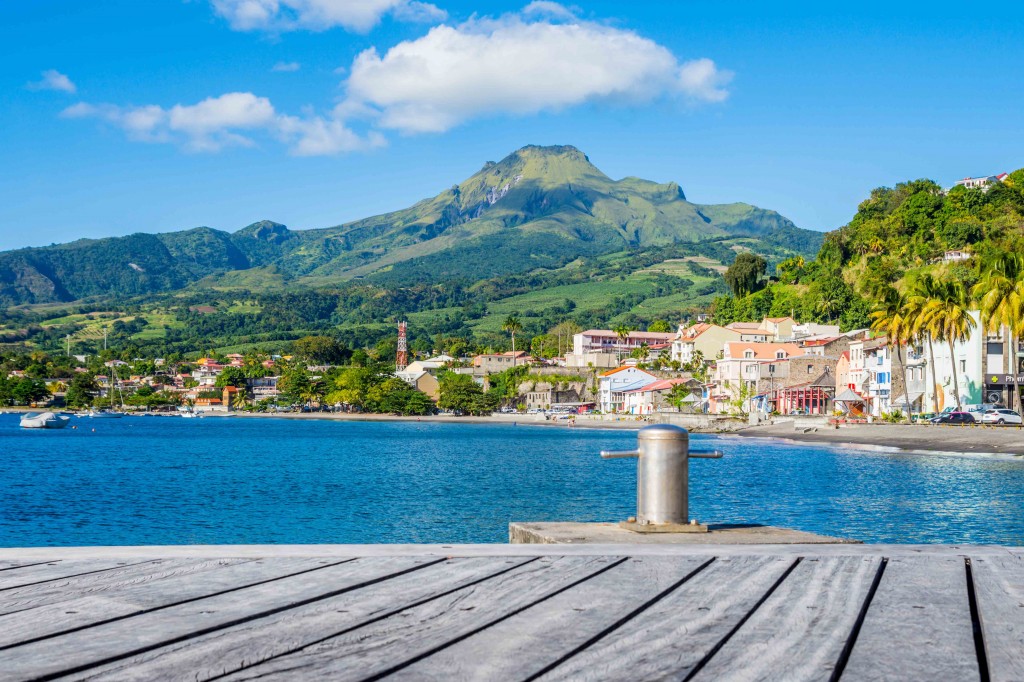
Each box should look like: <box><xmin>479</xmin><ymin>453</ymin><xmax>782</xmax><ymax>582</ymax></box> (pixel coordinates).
<box><xmin>601</xmin><ymin>424</ymin><xmax>722</xmax><ymax>532</ymax></box>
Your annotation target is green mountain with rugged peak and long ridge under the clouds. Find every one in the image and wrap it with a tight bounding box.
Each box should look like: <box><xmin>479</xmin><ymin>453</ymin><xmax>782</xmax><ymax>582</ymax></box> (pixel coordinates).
<box><xmin>0</xmin><ymin>146</ymin><xmax>822</xmax><ymax>305</ymax></box>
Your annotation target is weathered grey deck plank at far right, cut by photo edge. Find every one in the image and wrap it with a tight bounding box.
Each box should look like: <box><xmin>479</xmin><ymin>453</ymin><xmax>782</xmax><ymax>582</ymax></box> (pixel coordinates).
<box><xmin>971</xmin><ymin>557</ymin><xmax>1024</xmax><ymax>682</ymax></box>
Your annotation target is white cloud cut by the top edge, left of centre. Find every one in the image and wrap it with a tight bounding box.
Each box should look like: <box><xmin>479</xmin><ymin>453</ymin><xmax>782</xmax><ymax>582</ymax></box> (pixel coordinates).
<box><xmin>210</xmin><ymin>0</ymin><xmax>447</xmax><ymax>33</ymax></box>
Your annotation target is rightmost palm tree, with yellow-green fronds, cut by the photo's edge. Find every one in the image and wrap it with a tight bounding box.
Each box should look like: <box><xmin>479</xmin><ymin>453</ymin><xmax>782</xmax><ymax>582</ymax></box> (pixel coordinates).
<box><xmin>973</xmin><ymin>253</ymin><xmax>1024</xmax><ymax>409</ymax></box>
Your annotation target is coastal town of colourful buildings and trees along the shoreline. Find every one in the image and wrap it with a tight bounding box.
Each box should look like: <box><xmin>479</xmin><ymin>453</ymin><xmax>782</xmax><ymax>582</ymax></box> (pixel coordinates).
<box><xmin>6</xmin><ymin>301</ymin><xmax>1022</xmax><ymax>421</ymax></box>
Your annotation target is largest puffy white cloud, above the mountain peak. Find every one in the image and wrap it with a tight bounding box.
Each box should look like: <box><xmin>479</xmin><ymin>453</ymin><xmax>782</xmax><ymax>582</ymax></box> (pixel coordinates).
<box><xmin>346</xmin><ymin>11</ymin><xmax>731</xmax><ymax>133</ymax></box>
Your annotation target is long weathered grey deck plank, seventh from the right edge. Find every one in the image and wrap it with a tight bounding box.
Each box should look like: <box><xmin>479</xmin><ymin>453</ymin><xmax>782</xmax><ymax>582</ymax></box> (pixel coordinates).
<box><xmin>73</xmin><ymin>557</ymin><xmax>536</xmax><ymax>682</ymax></box>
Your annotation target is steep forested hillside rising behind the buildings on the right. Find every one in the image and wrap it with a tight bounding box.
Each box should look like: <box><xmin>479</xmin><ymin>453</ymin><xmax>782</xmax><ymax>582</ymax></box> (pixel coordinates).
<box><xmin>714</xmin><ymin>169</ymin><xmax>1024</xmax><ymax>329</ymax></box>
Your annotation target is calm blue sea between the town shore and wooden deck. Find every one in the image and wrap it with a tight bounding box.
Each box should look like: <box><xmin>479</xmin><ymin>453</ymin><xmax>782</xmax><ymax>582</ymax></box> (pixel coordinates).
<box><xmin>0</xmin><ymin>415</ymin><xmax>1024</xmax><ymax>546</ymax></box>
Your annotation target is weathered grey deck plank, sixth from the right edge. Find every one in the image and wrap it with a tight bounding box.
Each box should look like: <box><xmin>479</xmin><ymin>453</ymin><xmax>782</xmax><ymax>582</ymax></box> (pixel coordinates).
<box><xmin>217</xmin><ymin>557</ymin><xmax>625</xmax><ymax>680</ymax></box>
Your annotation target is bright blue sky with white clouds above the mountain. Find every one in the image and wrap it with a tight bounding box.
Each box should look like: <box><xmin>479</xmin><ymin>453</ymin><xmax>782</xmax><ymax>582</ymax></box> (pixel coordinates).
<box><xmin>0</xmin><ymin>0</ymin><xmax>1024</xmax><ymax>249</ymax></box>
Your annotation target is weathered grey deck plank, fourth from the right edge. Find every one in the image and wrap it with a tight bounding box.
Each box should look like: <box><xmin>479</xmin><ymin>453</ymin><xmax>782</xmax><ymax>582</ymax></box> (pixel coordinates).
<box><xmin>541</xmin><ymin>556</ymin><xmax>794</xmax><ymax>681</ymax></box>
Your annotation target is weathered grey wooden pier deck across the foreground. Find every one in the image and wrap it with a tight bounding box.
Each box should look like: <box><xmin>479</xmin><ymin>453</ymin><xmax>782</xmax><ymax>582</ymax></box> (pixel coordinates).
<box><xmin>0</xmin><ymin>545</ymin><xmax>1024</xmax><ymax>682</ymax></box>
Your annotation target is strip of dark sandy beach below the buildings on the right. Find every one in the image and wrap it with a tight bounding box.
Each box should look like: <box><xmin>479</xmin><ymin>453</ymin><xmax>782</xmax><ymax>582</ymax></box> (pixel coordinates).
<box><xmin>734</xmin><ymin>422</ymin><xmax>1024</xmax><ymax>457</ymax></box>
